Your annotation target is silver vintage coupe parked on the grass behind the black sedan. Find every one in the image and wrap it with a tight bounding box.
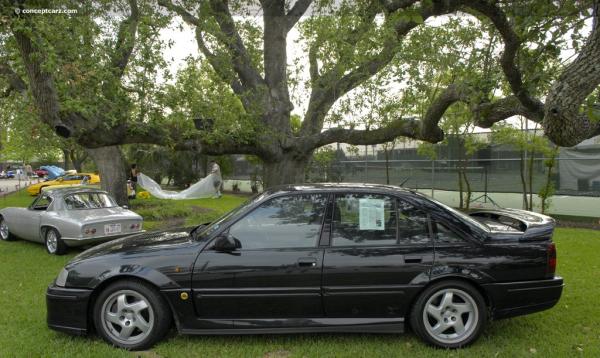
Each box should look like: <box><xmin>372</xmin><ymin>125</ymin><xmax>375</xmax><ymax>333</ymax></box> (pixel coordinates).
<box><xmin>0</xmin><ymin>188</ymin><xmax>143</xmax><ymax>255</ymax></box>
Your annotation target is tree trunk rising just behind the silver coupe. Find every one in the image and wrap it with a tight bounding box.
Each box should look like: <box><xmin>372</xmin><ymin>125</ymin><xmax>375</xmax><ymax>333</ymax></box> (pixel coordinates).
<box><xmin>86</xmin><ymin>146</ymin><xmax>127</xmax><ymax>205</ymax></box>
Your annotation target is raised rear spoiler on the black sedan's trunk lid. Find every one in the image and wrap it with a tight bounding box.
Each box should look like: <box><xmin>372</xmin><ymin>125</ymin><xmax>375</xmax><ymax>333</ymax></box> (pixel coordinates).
<box><xmin>469</xmin><ymin>209</ymin><xmax>556</xmax><ymax>240</ymax></box>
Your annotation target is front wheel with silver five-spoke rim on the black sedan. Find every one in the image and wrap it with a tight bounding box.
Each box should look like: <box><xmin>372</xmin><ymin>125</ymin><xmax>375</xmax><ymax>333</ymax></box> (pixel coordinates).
<box><xmin>93</xmin><ymin>280</ymin><xmax>172</xmax><ymax>351</ymax></box>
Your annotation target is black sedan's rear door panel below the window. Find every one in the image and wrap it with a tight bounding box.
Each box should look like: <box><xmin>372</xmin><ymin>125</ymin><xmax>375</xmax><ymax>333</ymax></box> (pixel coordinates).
<box><xmin>323</xmin><ymin>246</ymin><xmax>433</xmax><ymax>317</ymax></box>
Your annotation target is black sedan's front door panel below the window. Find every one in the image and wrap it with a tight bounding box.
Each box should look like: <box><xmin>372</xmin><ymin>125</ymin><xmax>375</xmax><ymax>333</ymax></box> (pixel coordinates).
<box><xmin>192</xmin><ymin>248</ymin><xmax>323</xmax><ymax>319</ymax></box>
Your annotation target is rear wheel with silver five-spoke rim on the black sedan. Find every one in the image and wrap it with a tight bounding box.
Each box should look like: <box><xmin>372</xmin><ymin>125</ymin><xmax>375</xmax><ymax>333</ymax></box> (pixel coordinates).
<box><xmin>410</xmin><ymin>280</ymin><xmax>488</xmax><ymax>349</ymax></box>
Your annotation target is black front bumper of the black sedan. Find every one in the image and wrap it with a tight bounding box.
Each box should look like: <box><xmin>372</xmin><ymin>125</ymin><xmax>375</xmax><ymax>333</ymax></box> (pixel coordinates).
<box><xmin>46</xmin><ymin>284</ymin><xmax>92</xmax><ymax>335</ymax></box>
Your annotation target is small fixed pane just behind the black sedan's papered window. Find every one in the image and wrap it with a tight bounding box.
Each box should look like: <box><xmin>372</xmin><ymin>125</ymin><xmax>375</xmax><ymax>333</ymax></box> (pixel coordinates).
<box><xmin>398</xmin><ymin>199</ymin><xmax>431</xmax><ymax>245</ymax></box>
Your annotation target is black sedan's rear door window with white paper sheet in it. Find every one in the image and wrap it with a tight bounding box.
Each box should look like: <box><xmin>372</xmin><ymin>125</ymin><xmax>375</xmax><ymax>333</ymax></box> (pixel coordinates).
<box><xmin>332</xmin><ymin>194</ymin><xmax>396</xmax><ymax>246</ymax></box>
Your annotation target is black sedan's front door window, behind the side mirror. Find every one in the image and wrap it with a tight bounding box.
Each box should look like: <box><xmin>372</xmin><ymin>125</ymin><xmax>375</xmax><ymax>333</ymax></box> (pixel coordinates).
<box><xmin>229</xmin><ymin>194</ymin><xmax>327</xmax><ymax>249</ymax></box>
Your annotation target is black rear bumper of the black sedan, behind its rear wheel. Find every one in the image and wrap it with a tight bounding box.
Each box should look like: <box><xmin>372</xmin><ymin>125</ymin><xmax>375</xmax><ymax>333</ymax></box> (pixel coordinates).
<box><xmin>483</xmin><ymin>276</ymin><xmax>564</xmax><ymax>319</ymax></box>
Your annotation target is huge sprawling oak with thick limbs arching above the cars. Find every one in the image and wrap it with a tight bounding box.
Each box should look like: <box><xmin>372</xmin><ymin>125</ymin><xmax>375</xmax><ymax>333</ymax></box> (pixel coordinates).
<box><xmin>0</xmin><ymin>0</ymin><xmax>600</xmax><ymax>199</ymax></box>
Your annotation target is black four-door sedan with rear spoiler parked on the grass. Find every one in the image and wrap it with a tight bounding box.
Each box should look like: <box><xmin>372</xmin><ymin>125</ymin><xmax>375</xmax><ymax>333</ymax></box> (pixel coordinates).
<box><xmin>47</xmin><ymin>184</ymin><xmax>563</xmax><ymax>350</ymax></box>
